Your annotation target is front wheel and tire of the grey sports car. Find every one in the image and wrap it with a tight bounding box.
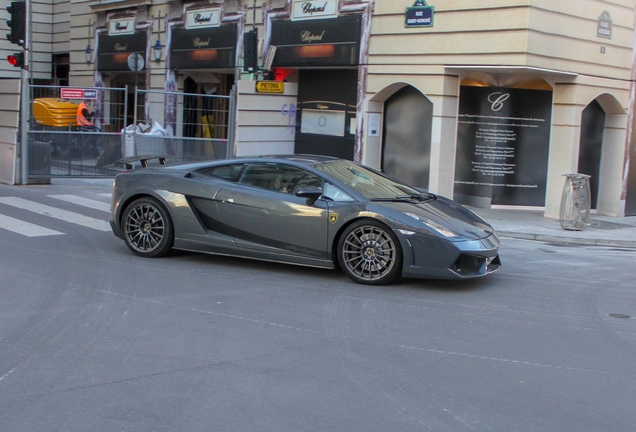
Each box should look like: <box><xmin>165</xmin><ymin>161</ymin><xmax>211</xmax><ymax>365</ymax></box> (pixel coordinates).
<box><xmin>338</xmin><ymin>220</ymin><xmax>402</xmax><ymax>285</ymax></box>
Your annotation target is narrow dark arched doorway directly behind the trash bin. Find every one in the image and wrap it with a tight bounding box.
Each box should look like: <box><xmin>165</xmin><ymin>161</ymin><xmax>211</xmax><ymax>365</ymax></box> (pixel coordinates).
<box><xmin>578</xmin><ymin>100</ymin><xmax>605</xmax><ymax>209</ymax></box>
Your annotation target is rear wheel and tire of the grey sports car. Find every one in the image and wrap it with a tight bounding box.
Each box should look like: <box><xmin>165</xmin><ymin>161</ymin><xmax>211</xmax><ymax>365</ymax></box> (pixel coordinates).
<box><xmin>122</xmin><ymin>198</ymin><xmax>174</xmax><ymax>258</ymax></box>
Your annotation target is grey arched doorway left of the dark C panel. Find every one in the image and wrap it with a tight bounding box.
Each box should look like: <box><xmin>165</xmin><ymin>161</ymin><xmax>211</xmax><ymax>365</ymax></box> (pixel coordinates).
<box><xmin>382</xmin><ymin>85</ymin><xmax>433</xmax><ymax>189</ymax></box>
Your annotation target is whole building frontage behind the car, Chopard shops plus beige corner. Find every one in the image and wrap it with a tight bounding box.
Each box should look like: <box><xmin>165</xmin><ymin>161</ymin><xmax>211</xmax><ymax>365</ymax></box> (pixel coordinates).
<box><xmin>3</xmin><ymin>0</ymin><xmax>636</xmax><ymax>217</ymax></box>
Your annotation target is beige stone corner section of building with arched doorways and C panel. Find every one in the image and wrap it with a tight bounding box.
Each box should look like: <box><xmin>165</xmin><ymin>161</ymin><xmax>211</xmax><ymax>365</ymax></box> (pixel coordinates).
<box><xmin>364</xmin><ymin>0</ymin><xmax>634</xmax><ymax>216</ymax></box>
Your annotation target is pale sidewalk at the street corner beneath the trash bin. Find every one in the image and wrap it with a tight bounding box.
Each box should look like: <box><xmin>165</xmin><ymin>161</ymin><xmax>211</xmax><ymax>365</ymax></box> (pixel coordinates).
<box><xmin>469</xmin><ymin>207</ymin><xmax>636</xmax><ymax>248</ymax></box>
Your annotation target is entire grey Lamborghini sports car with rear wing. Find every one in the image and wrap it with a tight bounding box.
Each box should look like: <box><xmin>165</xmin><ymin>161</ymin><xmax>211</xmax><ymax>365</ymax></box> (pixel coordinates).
<box><xmin>111</xmin><ymin>155</ymin><xmax>501</xmax><ymax>285</ymax></box>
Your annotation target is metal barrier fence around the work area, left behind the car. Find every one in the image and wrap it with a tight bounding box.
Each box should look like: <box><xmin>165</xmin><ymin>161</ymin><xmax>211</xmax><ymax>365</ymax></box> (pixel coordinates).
<box><xmin>28</xmin><ymin>86</ymin><xmax>234</xmax><ymax>179</ymax></box>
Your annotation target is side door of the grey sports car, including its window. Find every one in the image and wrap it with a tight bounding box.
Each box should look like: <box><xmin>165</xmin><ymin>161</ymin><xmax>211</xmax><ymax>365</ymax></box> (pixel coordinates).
<box><xmin>215</xmin><ymin>162</ymin><xmax>329</xmax><ymax>259</ymax></box>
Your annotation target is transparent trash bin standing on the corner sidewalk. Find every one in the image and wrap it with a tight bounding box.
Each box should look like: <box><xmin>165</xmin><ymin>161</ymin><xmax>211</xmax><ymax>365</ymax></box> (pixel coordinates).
<box><xmin>559</xmin><ymin>173</ymin><xmax>592</xmax><ymax>231</ymax></box>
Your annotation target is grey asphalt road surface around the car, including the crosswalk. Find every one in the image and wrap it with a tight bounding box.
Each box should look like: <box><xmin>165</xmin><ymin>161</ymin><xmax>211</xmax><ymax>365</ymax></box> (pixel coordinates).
<box><xmin>0</xmin><ymin>181</ymin><xmax>636</xmax><ymax>432</ymax></box>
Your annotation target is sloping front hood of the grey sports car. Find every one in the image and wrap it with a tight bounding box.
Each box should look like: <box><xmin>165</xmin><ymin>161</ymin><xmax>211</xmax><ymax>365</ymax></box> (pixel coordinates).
<box><xmin>382</xmin><ymin>196</ymin><xmax>494</xmax><ymax>240</ymax></box>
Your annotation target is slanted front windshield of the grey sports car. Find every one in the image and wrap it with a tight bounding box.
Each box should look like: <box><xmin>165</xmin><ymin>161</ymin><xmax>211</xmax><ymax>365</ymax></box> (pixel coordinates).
<box><xmin>314</xmin><ymin>160</ymin><xmax>435</xmax><ymax>201</ymax></box>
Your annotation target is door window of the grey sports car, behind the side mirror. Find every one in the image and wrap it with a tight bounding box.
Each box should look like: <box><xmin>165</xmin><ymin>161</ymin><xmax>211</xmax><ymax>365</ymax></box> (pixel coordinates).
<box><xmin>239</xmin><ymin>163</ymin><xmax>322</xmax><ymax>194</ymax></box>
